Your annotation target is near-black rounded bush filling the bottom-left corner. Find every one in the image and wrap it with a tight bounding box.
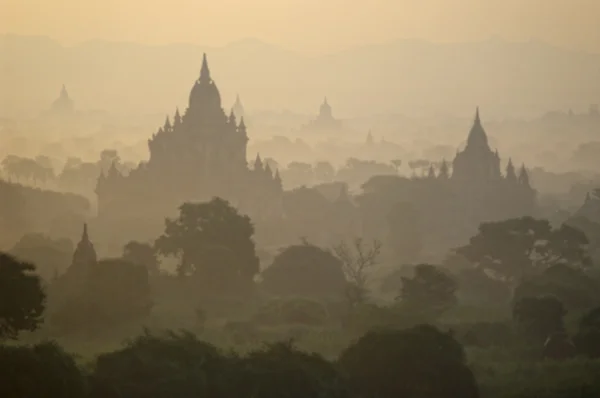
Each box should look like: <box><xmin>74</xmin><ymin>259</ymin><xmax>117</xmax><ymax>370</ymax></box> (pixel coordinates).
<box><xmin>0</xmin><ymin>343</ymin><xmax>87</xmax><ymax>398</ymax></box>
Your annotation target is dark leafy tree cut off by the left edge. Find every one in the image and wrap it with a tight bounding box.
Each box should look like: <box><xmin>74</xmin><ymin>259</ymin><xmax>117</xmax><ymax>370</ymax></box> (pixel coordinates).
<box><xmin>0</xmin><ymin>253</ymin><xmax>46</xmax><ymax>339</ymax></box>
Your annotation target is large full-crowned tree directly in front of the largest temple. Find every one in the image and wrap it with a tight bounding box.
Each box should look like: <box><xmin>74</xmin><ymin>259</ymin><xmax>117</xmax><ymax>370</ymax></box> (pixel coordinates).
<box><xmin>155</xmin><ymin>198</ymin><xmax>259</xmax><ymax>292</ymax></box>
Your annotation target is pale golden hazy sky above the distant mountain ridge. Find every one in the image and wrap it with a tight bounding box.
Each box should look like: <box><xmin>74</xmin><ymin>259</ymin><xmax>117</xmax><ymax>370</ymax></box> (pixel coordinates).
<box><xmin>0</xmin><ymin>0</ymin><xmax>600</xmax><ymax>52</ymax></box>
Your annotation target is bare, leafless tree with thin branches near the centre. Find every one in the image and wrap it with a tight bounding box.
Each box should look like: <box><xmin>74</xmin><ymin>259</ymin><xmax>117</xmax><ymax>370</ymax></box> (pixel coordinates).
<box><xmin>333</xmin><ymin>238</ymin><xmax>381</xmax><ymax>304</ymax></box>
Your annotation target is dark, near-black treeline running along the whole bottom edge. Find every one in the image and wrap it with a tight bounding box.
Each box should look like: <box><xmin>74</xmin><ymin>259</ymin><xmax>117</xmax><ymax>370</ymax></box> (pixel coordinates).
<box><xmin>0</xmin><ymin>325</ymin><xmax>600</xmax><ymax>398</ymax></box>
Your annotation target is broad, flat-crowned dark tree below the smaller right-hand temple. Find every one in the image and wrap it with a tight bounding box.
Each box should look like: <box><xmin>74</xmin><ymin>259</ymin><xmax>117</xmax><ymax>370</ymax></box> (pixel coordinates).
<box><xmin>456</xmin><ymin>217</ymin><xmax>591</xmax><ymax>283</ymax></box>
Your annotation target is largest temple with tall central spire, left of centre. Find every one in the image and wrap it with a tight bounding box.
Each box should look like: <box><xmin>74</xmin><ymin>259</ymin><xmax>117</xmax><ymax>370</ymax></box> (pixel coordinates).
<box><xmin>96</xmin><ymin>54</ymin><xmax>283</xmax><ymax>236</ymax></box>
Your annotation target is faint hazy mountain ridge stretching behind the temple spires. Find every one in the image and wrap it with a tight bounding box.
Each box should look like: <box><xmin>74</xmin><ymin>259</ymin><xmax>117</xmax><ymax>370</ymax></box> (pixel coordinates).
<box><xmin>0</xmin><ymin>35</ymin><xmax>600</xmax><ymax>117</ymax></box>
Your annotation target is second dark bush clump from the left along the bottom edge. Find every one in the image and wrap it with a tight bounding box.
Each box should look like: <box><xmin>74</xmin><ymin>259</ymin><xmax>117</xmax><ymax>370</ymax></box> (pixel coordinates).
<box><xmin>91</xmin><ymin>333</ymin><xmax>230</xmax><ymax>398</ymax></box>
